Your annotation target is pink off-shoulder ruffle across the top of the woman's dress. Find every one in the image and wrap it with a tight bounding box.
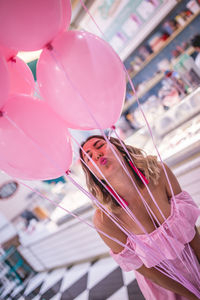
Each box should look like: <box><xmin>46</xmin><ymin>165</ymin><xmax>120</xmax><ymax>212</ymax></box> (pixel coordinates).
<box><xmin>110</xmin><ymin>191</ymin><xmax>200</xmax><ymax>271</ymax></box>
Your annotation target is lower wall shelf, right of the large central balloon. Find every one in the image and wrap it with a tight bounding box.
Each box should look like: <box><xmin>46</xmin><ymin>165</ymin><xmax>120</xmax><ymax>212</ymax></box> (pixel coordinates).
<box><xmin>122</xmin><ymin>46</ymin><xmax>195</xmax><ymax>113</ymax></box>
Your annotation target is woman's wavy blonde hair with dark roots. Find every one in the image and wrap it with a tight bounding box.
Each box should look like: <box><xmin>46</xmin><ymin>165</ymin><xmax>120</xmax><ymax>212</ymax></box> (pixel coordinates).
<box><xmin>80</xmin><ymin>135</ymin><xmax>160</xmax><ymax>210</ymax></box>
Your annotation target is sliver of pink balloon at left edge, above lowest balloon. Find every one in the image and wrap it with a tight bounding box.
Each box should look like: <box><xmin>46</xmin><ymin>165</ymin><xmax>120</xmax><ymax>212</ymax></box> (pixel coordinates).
<box><xmin>0</xmin><ymin>56</ymin><xmax>10</xmax><ymax>110</ymax></box>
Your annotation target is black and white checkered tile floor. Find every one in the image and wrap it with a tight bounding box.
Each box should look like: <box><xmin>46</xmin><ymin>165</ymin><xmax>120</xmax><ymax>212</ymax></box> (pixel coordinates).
<box><xmin>8</xmin><ymin>257</ymin><xmax>144</xmax><ymax>300</ymax></box>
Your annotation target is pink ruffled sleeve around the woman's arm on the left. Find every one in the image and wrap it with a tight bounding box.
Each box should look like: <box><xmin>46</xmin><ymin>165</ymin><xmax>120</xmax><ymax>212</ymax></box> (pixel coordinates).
<box><xmin>110</xmin><ymin>238</ymin><xmax>143</xmax><ymax>272</ymax></box>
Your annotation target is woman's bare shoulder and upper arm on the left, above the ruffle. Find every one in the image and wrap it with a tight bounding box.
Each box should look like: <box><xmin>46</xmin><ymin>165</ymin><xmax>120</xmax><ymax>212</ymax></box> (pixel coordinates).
<box><xmin>93</xmin><ymin>209</ymin><xmax>127</xmax><ymax>253</ymax></box>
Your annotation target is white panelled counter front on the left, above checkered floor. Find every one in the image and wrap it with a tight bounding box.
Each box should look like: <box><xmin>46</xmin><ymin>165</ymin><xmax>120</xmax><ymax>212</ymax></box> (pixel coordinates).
<box><xmin>18</xmin><ymin>210</ymin><xmax>108</xmax><ymax>271</ymax></box>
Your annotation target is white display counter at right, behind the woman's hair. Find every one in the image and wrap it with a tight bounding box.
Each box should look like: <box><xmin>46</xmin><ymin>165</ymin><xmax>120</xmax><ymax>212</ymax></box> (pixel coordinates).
<box><xmin>125</xmin><ymin>87</ymin><xmax>200</xmax><ymax>165</ymax></box>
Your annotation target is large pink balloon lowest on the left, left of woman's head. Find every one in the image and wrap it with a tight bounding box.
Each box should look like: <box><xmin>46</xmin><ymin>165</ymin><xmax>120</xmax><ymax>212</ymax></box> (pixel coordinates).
<box><xmin>0</xmin><ymin>95</ymin><xmax>72</xmax><ymax>180</ymax></box>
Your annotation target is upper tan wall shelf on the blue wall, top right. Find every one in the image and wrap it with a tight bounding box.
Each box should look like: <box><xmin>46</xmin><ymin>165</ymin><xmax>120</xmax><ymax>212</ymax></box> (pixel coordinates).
<box><xmin>126</xmin><ymin>12</ymin><xmax>200</xmax><ymax>78</ymax></box>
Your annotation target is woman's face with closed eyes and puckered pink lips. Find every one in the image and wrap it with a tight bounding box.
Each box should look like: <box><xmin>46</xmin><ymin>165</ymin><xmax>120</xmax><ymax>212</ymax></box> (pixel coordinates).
<box><xmin>82</xmin><ymin>138</ymin><xmax>122</xmax><ymax>179</ymax></box>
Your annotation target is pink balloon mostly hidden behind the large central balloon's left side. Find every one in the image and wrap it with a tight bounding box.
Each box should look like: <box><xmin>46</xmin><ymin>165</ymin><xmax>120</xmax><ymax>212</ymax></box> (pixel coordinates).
<box><xmin>7</xmin><ymin>57</ymin><xmax>35</xmax><ymax>95</ymax></box>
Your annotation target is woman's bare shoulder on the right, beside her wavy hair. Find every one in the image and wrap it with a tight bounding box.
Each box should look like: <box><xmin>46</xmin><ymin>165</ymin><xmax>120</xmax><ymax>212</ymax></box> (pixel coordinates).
<box><xmin>159</xmin><ymin>163</ymin><xmax>182</xmax><ymax>198</ymax></box>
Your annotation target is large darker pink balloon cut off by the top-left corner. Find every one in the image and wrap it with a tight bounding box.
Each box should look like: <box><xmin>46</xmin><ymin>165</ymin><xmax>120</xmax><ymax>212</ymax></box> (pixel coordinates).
<box><xmin>0</xmin><ymin>0</ymin><xmax>71</xmax><ymax>51</ymax></box>
